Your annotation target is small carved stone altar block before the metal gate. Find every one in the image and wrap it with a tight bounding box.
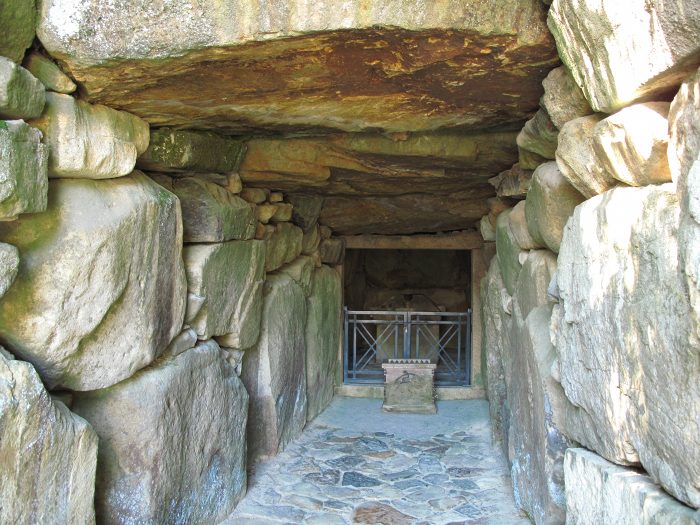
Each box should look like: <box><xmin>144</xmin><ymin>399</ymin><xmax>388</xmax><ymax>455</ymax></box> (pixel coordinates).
<box><xmin>382</xmin><ymin>359</ymin><xmax>437</xmax><ymax>414</ymax></box>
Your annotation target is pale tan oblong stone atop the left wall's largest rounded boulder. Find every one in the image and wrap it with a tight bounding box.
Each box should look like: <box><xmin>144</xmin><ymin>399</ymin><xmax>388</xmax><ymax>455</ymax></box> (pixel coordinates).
<box><xmin>30</xmin><ymin>92</ymin><xmax>148</xmax><ymax>179</ymax></box>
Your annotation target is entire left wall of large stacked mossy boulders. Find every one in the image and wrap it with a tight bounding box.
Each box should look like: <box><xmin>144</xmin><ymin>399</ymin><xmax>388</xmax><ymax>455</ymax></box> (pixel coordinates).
<box><xmin>0</xmin><ymin>25</ymin><xmax>341</xmax><ymax>524</ymax></box>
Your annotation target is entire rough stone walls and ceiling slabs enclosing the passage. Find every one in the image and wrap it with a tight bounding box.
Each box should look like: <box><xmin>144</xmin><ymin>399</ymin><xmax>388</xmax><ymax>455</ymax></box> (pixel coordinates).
<box><xmin>0</xmin><ymin>0</ymin><xmax>700</xmax><ymax>524</ymax></box>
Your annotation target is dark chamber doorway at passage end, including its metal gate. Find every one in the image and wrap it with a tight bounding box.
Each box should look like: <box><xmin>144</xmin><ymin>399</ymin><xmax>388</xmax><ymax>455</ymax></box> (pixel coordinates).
<box><xmin>343</xmin><ymin>249</ymin><xmax>471</xmax><ymax>386</ymax></box>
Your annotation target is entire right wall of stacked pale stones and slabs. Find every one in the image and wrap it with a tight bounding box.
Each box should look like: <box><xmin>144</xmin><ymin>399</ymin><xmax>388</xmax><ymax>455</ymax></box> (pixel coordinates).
<box><xmin>482</xmin><ymin>0</ymin><xmax>700</xmax><ymax>523</ymax></box>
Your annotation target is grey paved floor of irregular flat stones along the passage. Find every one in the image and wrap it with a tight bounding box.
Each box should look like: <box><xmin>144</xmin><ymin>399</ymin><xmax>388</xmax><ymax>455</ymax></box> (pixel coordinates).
<box><xmin>225</xmin><ymin>398</ymin><xmax>529</xmax><ymax>525</ymax></box>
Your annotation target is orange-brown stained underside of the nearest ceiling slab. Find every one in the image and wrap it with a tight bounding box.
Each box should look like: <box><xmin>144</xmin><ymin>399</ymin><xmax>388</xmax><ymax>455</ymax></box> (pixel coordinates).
<box><xmin>41</xmin><ymin>28</ymin><xmax>558</xmax><ymax>133</ymax></box>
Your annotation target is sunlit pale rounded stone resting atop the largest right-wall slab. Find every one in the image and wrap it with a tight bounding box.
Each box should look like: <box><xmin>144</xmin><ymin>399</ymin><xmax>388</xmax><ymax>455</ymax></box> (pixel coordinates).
<box><xmin>592</xmin><ymin>102</ymin><xmax>671</xmax><ymax>186</ymax></box>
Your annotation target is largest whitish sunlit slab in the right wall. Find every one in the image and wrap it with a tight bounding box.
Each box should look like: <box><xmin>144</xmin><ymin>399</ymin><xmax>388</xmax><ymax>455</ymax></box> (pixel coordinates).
<box><xmin>555</xmin><ymin>185</ymin><xmax>700</xmax><ymax>507</ymax></box>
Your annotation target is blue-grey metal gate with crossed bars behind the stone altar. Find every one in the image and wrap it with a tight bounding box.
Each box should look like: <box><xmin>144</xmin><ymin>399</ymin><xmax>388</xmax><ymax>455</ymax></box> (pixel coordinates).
<box><xmin>343</xmin><ymin>308</ymin><xmax>471</xmax><ymax>386</ymax></box>
